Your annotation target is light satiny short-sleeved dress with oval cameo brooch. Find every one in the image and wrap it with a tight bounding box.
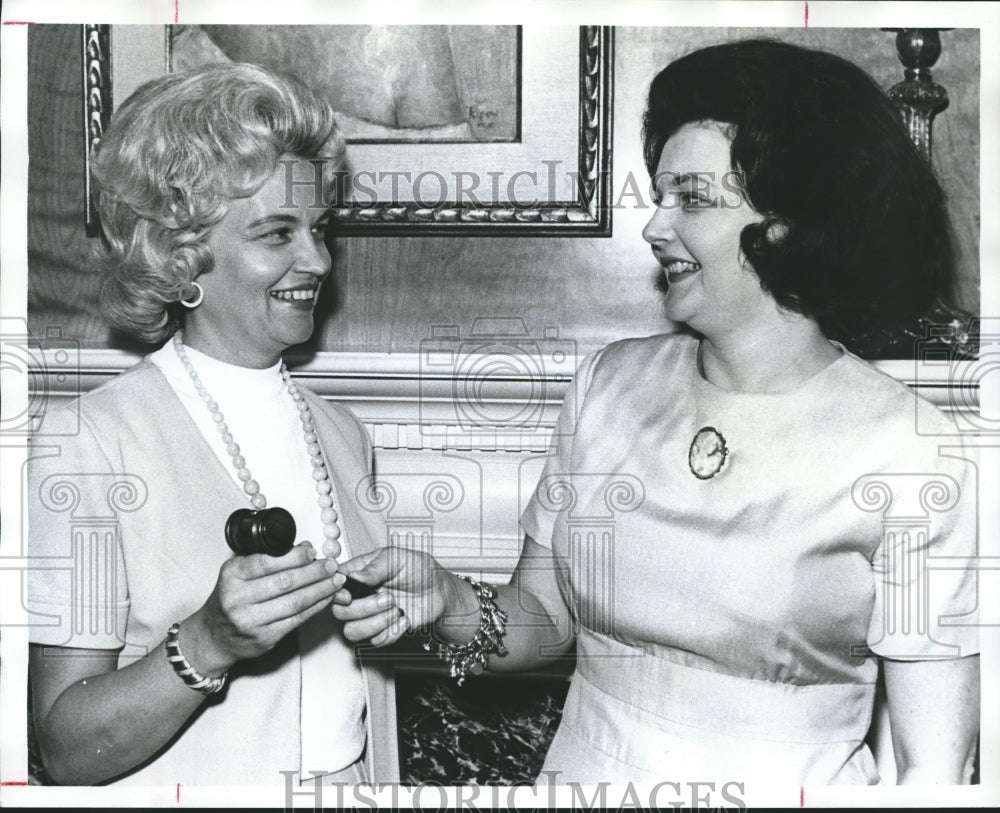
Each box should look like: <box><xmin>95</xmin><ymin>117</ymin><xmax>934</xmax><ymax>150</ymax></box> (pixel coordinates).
<box><xmin>522</xmin><ymin>334</ymin><xmax>978</xmax><ymax>785</ymax></box>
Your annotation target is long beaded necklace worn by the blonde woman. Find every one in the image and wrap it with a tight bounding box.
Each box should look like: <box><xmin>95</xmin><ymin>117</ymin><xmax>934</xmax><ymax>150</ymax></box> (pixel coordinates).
<box><xmin>174</xmin><ymin>331</ymin><xmax>341</xmax><ymax>559</ymax></box>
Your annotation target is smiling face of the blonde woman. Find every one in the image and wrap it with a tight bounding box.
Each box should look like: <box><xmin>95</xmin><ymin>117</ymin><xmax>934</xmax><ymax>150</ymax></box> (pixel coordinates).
<box><xmin>184</xmin><ymin>156</ymin><xmax>331</xmax><ymax>368</ymax></box>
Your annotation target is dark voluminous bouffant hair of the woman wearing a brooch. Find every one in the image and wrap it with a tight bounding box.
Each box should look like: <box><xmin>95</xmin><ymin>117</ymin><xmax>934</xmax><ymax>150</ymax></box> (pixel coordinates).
<box><xmin>643</xmin><ymin>39</ymin><xmax>952</xmax><ymax>339</ymax></box>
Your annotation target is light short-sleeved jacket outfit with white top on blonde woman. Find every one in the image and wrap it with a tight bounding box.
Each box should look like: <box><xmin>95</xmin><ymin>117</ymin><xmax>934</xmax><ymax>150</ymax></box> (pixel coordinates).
<box><xmin>28</xmin><ymin>356</ymin><xmax>398</xmax><ymax>788</ymax></box>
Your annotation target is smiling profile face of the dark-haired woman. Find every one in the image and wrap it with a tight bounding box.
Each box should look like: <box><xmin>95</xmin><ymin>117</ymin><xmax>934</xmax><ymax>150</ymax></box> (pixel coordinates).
<box><xmin>642</xmin><ymin>122</ymin><xmax>774</xmax><ymax>338</ymax></box>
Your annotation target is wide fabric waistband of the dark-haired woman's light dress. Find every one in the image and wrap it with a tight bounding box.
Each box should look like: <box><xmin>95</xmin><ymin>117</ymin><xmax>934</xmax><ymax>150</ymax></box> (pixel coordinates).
<box><xmin>575</xmin><ymin>631</ymin><xmax>875</xmax><ymax>743</ymax></box>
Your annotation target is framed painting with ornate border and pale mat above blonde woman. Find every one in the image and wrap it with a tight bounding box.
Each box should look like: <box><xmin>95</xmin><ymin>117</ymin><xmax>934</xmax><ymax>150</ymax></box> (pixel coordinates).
<box><xmin>83</xmin><ymin>25</ymin><xmax>613</xmax><ymax>237</ymax></box>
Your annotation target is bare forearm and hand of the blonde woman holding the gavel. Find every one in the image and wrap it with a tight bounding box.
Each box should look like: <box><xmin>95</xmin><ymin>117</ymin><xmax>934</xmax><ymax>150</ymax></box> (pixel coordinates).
<box><xmin>31</xmin><ymin>543</ymin><xmax>344</xmax><ymax>784</ymax></box>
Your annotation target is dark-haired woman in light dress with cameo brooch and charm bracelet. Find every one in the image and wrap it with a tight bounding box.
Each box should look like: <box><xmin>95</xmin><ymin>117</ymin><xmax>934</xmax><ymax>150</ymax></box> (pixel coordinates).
<box><xmin>336</xmin><ymin>41</ymin><xmax>979</xmax><ymax>786</ymax></box>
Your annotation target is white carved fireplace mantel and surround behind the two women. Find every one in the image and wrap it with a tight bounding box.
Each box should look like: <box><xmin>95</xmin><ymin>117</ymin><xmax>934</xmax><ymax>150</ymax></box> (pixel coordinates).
<box><xmin>23</xmin><ymin>350</ymin><xmax>988</xmax><ymax>581</ymax></box>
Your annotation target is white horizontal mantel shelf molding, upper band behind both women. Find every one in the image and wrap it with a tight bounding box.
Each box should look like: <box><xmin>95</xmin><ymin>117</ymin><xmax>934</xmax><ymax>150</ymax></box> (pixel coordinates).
<box><xmin>30</xmin><ymin>343</ymin><xmax>976</xmax><ymax>428</ymax></box>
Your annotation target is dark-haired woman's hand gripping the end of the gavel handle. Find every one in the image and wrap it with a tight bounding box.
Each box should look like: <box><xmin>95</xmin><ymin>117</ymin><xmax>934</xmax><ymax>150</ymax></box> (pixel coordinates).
<box><xmin>333</xmin><ymin>547</ymin><xmax>454</xmax><ymax>646</ymax></box>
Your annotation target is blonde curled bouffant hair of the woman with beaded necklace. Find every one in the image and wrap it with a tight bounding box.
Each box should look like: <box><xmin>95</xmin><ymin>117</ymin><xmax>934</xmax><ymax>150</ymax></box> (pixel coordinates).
<box><xmin>94</xmin><ymin>63</ymin><xmax>345</xmax><ymax>343</ymax></box>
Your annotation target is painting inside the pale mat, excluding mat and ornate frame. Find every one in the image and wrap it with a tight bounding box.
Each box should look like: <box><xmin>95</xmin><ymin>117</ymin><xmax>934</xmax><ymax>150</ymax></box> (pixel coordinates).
<box><xmin>169</xmin><ymin>25</ymin><xmax>521</xmax><ymax>143</ymax></box>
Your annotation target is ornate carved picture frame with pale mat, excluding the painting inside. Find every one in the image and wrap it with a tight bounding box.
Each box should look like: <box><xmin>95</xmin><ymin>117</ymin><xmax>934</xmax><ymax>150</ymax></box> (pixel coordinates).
<box><xmin>82</xmin><ymin>25</ymin><xmax>614</xmax><ymax>237</ymax></box>
